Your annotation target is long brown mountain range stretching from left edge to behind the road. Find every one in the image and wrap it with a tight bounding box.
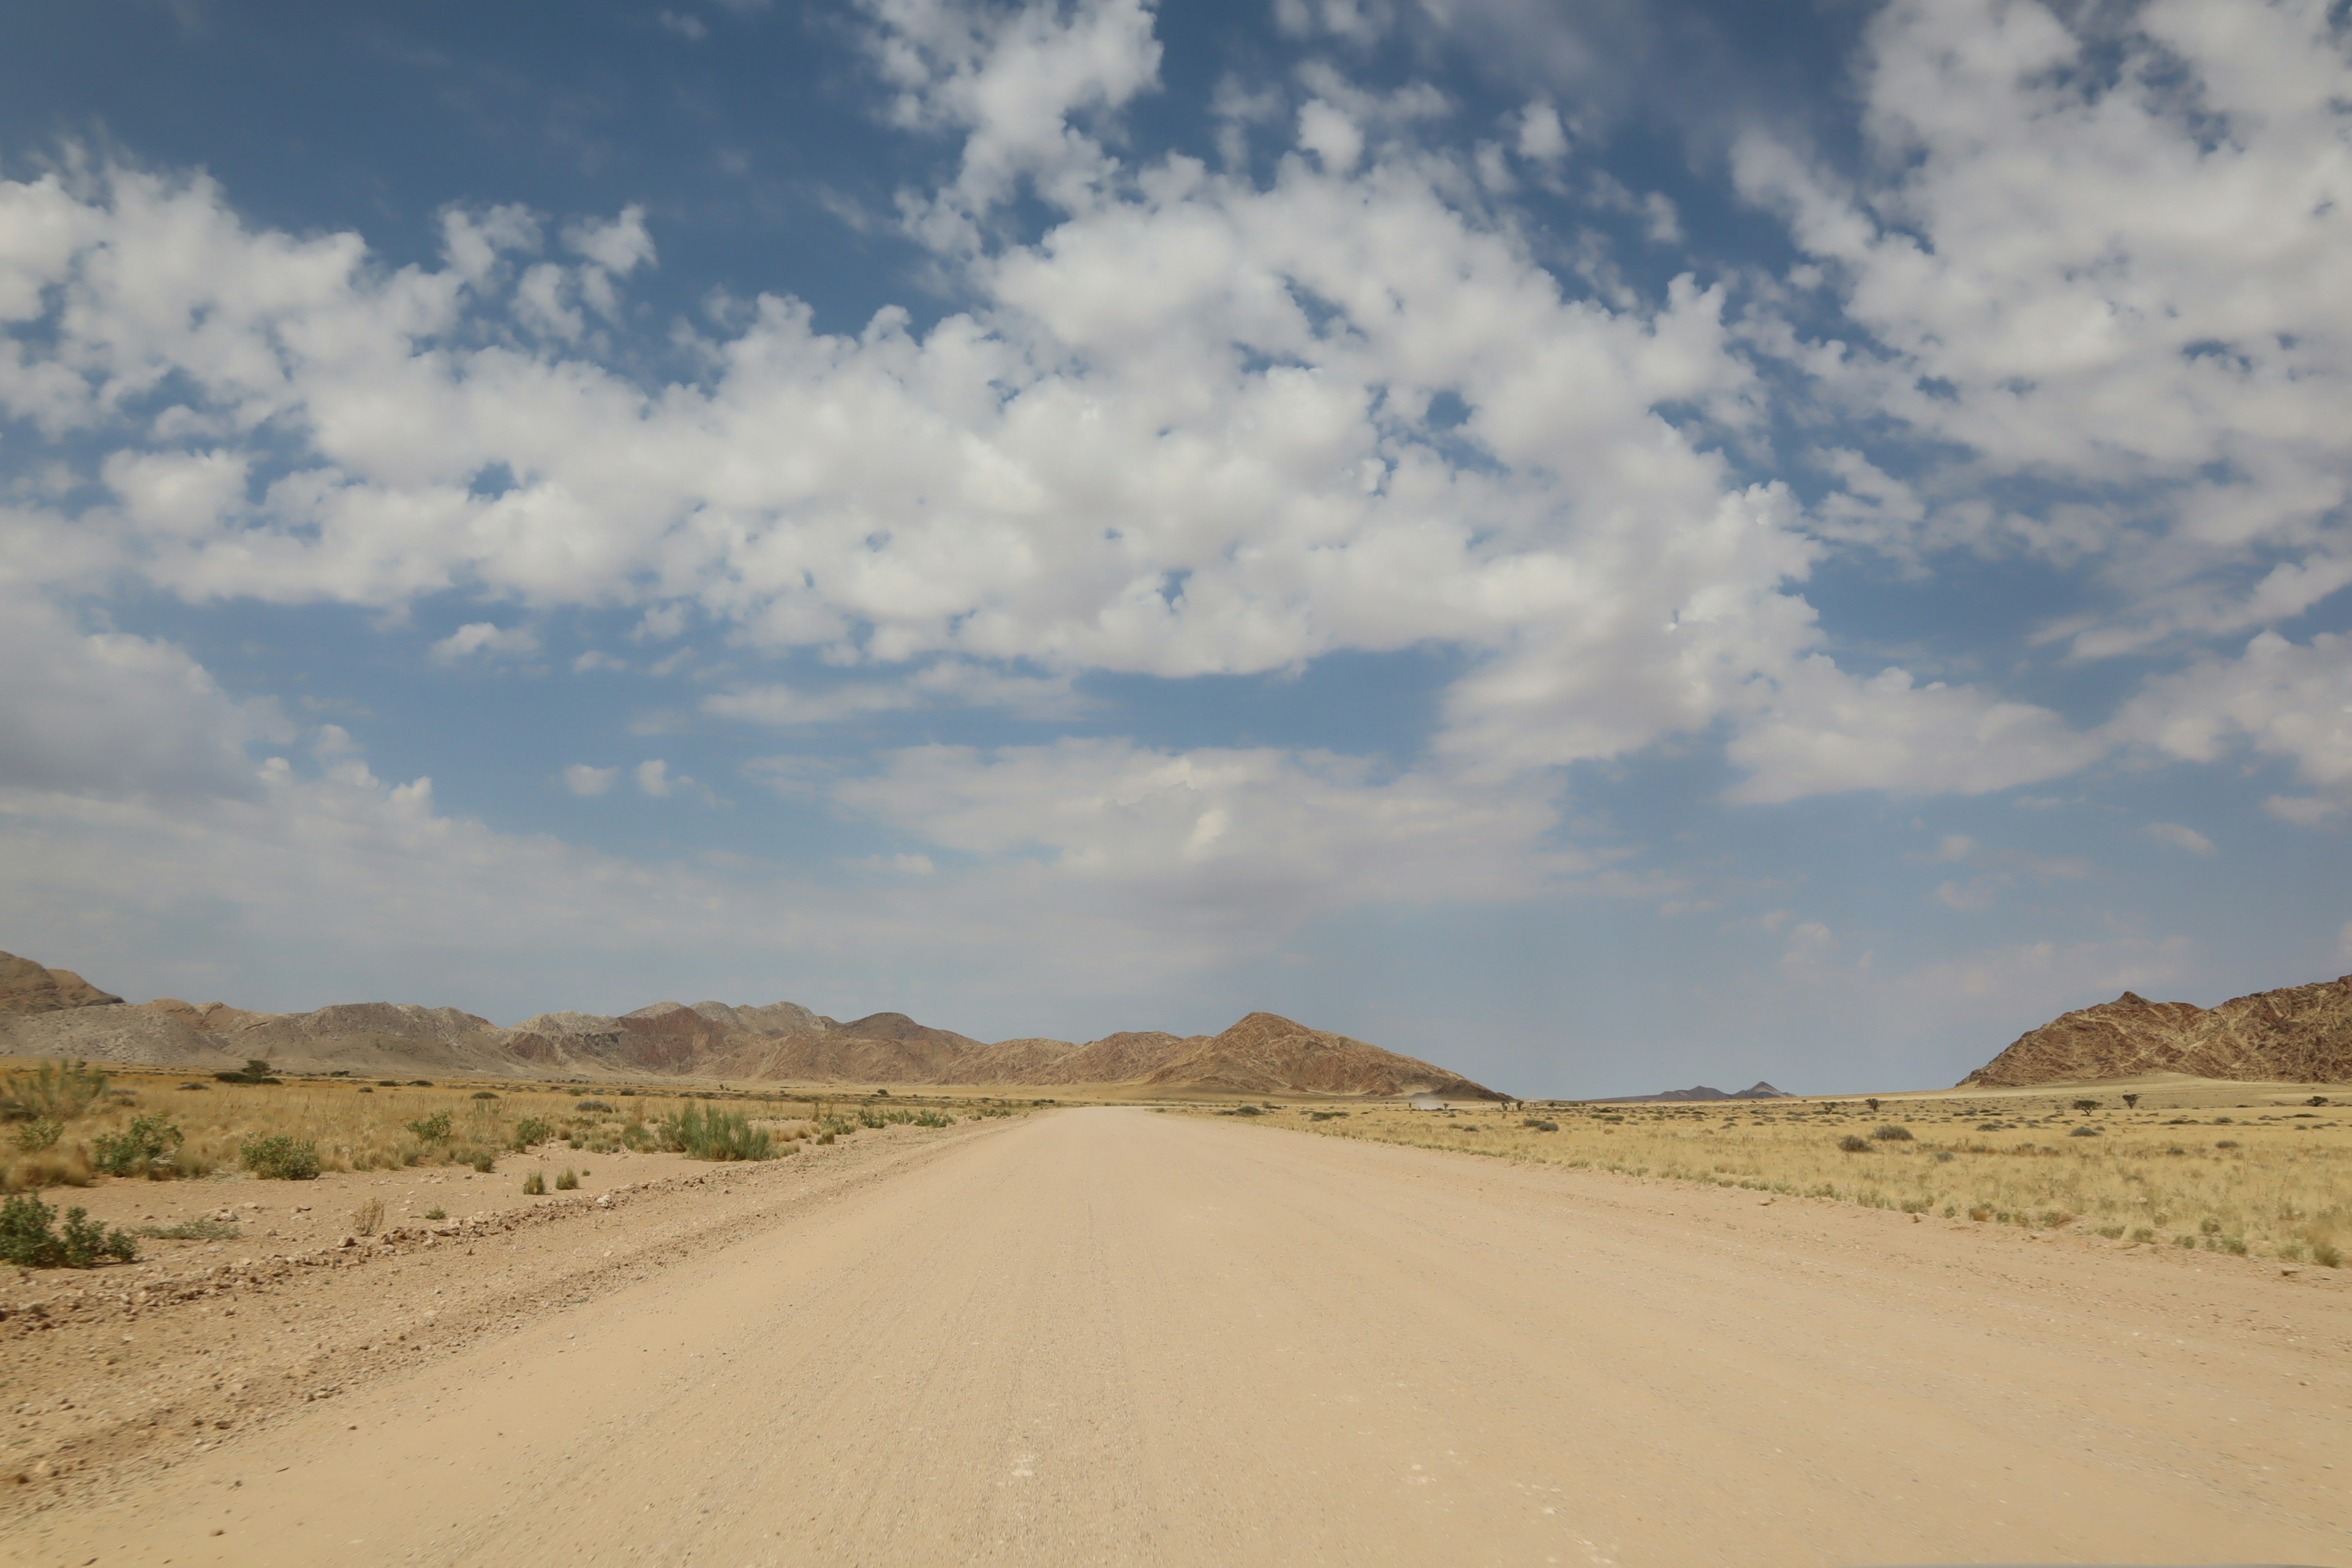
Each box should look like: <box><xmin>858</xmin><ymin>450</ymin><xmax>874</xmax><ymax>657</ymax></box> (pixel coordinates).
<box><xmin>0</xmin><ymin>954</ymin><xmax>1506</xmax><ymax>1100</ymax></box>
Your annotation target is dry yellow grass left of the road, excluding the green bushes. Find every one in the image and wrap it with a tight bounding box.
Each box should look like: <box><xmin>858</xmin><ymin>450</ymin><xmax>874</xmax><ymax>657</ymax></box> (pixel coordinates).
<box><xmin>0</xmin><ymin>1063</ymin><xmax>997</xmax><ymax>1192</ymax></box>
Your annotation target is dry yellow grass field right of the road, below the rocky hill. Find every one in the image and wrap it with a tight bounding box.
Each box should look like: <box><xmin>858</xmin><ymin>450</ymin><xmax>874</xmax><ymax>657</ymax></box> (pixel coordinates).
<box><xmin>1232</xmin><ymin>1084</ymin><xmax>2352</xmax><ymax>1267</ymax></box>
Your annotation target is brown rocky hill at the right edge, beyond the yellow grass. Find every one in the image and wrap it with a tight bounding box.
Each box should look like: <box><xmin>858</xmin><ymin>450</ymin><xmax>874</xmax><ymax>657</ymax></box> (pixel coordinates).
<box><xmin>1962</xmin><ymin>976</ymin><xmax>2352</xmax><ymax>1088</ymax></box>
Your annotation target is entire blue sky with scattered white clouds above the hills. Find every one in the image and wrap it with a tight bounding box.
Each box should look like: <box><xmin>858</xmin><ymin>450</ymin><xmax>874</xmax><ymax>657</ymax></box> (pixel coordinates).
<box><xmin>0</xmin><ymin>0</ymin><xmax>2352</xmax><ymax>1093</ymax></box>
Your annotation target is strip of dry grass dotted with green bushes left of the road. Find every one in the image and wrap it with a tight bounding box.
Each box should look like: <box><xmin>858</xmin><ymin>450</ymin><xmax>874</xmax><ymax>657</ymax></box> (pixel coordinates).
<box><xmin>0</xmin><ymin>1060</ymin><xmax>1014</xmax><ymax>1192</ymax></box>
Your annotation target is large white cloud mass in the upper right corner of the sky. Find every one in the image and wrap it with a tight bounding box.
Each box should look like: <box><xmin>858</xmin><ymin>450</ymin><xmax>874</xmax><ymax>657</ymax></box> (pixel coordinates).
<box><xmin>1733</xmin><ymin>0</ymin><xmax>2352</xmax><ymax>658</ymax></box>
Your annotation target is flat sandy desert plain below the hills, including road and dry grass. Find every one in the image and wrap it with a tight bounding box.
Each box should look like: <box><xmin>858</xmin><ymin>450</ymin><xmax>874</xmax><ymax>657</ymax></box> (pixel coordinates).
<box><xmin>0</xmin><ymin>1072</ymin><xmax>2352</xmax><ymax>1566</ymax></box>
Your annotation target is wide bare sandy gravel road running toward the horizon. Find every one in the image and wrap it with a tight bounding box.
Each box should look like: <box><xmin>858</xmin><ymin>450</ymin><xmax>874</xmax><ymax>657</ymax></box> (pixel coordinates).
<box><xmin>0</xmin><ymin>1110</ymin><xmax>2352</xmax><ymax>1568</ymax></box>
